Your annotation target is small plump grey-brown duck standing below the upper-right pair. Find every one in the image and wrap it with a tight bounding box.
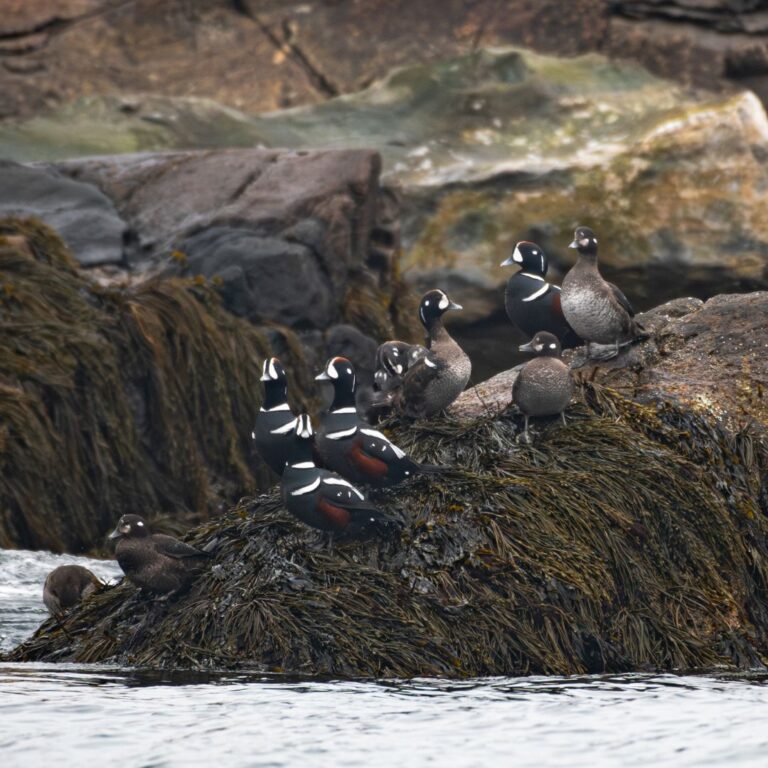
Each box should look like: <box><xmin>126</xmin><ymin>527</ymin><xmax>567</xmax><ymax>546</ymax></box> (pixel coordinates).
<box><xmin>512</xmin><ymin>331</ymin><xmax>573</xmax><ymax>442</ymax></box>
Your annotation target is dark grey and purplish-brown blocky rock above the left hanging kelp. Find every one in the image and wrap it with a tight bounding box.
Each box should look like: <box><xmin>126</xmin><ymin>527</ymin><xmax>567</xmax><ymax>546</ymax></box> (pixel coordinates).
<box><xmin>0</xmin><ymin>149</ymin><xmax>410</xmax><ymax>400</ymax></box>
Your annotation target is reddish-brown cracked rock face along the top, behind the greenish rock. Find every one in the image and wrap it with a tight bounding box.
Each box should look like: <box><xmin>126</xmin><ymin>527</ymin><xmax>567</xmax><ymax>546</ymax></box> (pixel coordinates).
<box><xmin>0</xmin><ymin>0</ymin><xmax>768</xmax><ymax>127</ymax></box>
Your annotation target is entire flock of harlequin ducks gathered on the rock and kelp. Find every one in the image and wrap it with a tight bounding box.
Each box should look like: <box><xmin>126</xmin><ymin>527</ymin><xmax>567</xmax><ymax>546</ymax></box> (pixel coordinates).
<box><xmin>43</xmin><ymin>227</ymin><xmax>644</xmax><ymax>615</ymax></box>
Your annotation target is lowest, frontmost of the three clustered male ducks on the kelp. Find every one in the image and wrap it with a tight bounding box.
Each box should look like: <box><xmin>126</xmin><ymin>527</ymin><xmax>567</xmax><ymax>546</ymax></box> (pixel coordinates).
<box><xmin>282</xmin><ymin>414</ymin><xmax>395</xmax><ymax>536</ymax></box>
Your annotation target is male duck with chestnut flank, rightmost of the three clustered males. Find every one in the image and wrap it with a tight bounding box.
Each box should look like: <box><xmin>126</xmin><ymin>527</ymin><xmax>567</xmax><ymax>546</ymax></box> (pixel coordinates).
<box><xmin>315</xmin><ymin>357</ymin><xmax>440</xmax><ymax>487</ymax></box>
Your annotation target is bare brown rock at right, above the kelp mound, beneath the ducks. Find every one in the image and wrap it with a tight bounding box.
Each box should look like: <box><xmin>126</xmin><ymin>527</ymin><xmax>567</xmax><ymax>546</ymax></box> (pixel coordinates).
<box><xmin>451</xmin><ymin>292</ymin><xmax>768</xmax><ymax>438</ymax></box>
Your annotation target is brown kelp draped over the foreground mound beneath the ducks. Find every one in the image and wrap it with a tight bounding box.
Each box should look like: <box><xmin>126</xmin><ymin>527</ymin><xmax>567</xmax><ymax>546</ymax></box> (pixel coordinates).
<box><xmin>8</xmin><ymin>384</ymin><xmax>768</xmax><ymax>677</ymax></box>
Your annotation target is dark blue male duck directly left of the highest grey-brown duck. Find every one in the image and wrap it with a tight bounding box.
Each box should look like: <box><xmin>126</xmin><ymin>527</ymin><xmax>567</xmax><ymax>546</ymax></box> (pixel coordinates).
<box><xmin>501</xmin><ymin>240</ymin><xmax>581</xmax><ymax>348</ymax></box>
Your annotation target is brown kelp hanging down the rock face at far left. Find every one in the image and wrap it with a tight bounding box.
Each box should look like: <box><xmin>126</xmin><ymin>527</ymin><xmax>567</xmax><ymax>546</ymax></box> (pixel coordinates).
<box><xmin>0</xmin><ymin>219</ymin><xmax>316</xmax><ymax>551</ymax></box>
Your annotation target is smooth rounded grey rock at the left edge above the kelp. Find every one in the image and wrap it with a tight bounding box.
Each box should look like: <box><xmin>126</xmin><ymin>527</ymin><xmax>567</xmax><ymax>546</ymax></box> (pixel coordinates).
<box><xmin>0</xmin><ymin>160</ymin><xmax>127</xmax><ymax>267</ymax></box>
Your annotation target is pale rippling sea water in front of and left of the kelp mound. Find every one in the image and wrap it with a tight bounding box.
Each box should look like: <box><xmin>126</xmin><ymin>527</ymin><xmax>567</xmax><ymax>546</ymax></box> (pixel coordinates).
<box><xmin>0</xmin><ymin>551</ymin><xmax>768</xmax><ymax>768</ymax></box>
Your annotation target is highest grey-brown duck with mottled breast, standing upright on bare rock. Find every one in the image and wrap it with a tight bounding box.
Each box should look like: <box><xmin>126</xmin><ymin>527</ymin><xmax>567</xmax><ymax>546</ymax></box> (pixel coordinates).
<box><xmin>560</xmin><ymin>227</ymin><xmax>644</xmax><ymax>357</ymax></box>
